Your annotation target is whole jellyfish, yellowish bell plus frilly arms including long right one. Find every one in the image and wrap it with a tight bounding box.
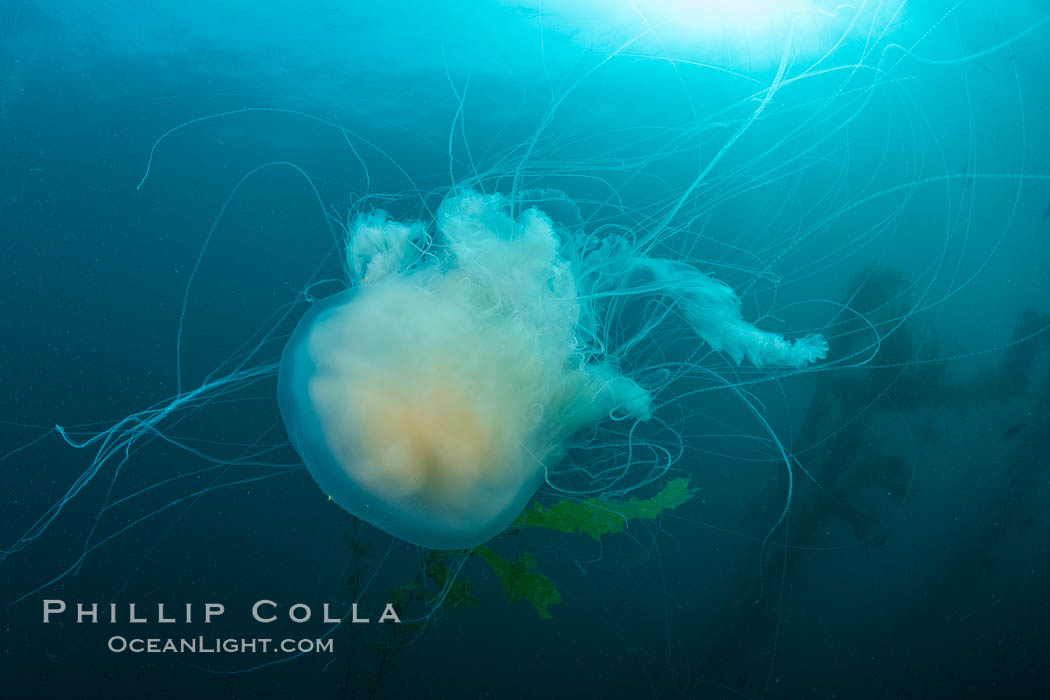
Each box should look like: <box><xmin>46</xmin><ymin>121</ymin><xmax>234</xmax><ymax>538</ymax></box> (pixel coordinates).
<box><xmin>278</xmin><ymin>190</ymin><xmax>827</xmax><ymax>549</ymax></box>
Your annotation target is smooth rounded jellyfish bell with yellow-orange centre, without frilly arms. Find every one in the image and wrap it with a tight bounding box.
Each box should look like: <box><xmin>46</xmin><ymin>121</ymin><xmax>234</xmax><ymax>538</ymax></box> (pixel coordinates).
<box><xmin>279</xmin><ymin>282</ymin><xmax>542</xmax><ymax>548</ymax></box>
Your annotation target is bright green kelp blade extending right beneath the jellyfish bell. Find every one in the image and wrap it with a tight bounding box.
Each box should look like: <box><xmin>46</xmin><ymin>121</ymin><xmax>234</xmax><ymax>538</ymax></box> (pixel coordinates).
<box><xmin>512</xmin><ymin>476</ymin><xmax>697</xmax><ymax>539</ymax></box>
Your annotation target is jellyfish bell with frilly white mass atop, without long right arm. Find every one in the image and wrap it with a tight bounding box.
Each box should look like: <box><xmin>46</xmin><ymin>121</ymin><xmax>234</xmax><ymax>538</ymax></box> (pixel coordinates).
<box><xmin>279</xmin><ymin>193</ymin><xmax>641</xmax><ymax>548</ymax></box>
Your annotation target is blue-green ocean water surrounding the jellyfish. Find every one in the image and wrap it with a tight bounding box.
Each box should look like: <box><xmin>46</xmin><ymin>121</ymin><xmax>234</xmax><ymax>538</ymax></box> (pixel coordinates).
<box><xmin>0</xmin><ymin>0</ymin><xmax>1050</xmax><ymax>698</ymax></box>
